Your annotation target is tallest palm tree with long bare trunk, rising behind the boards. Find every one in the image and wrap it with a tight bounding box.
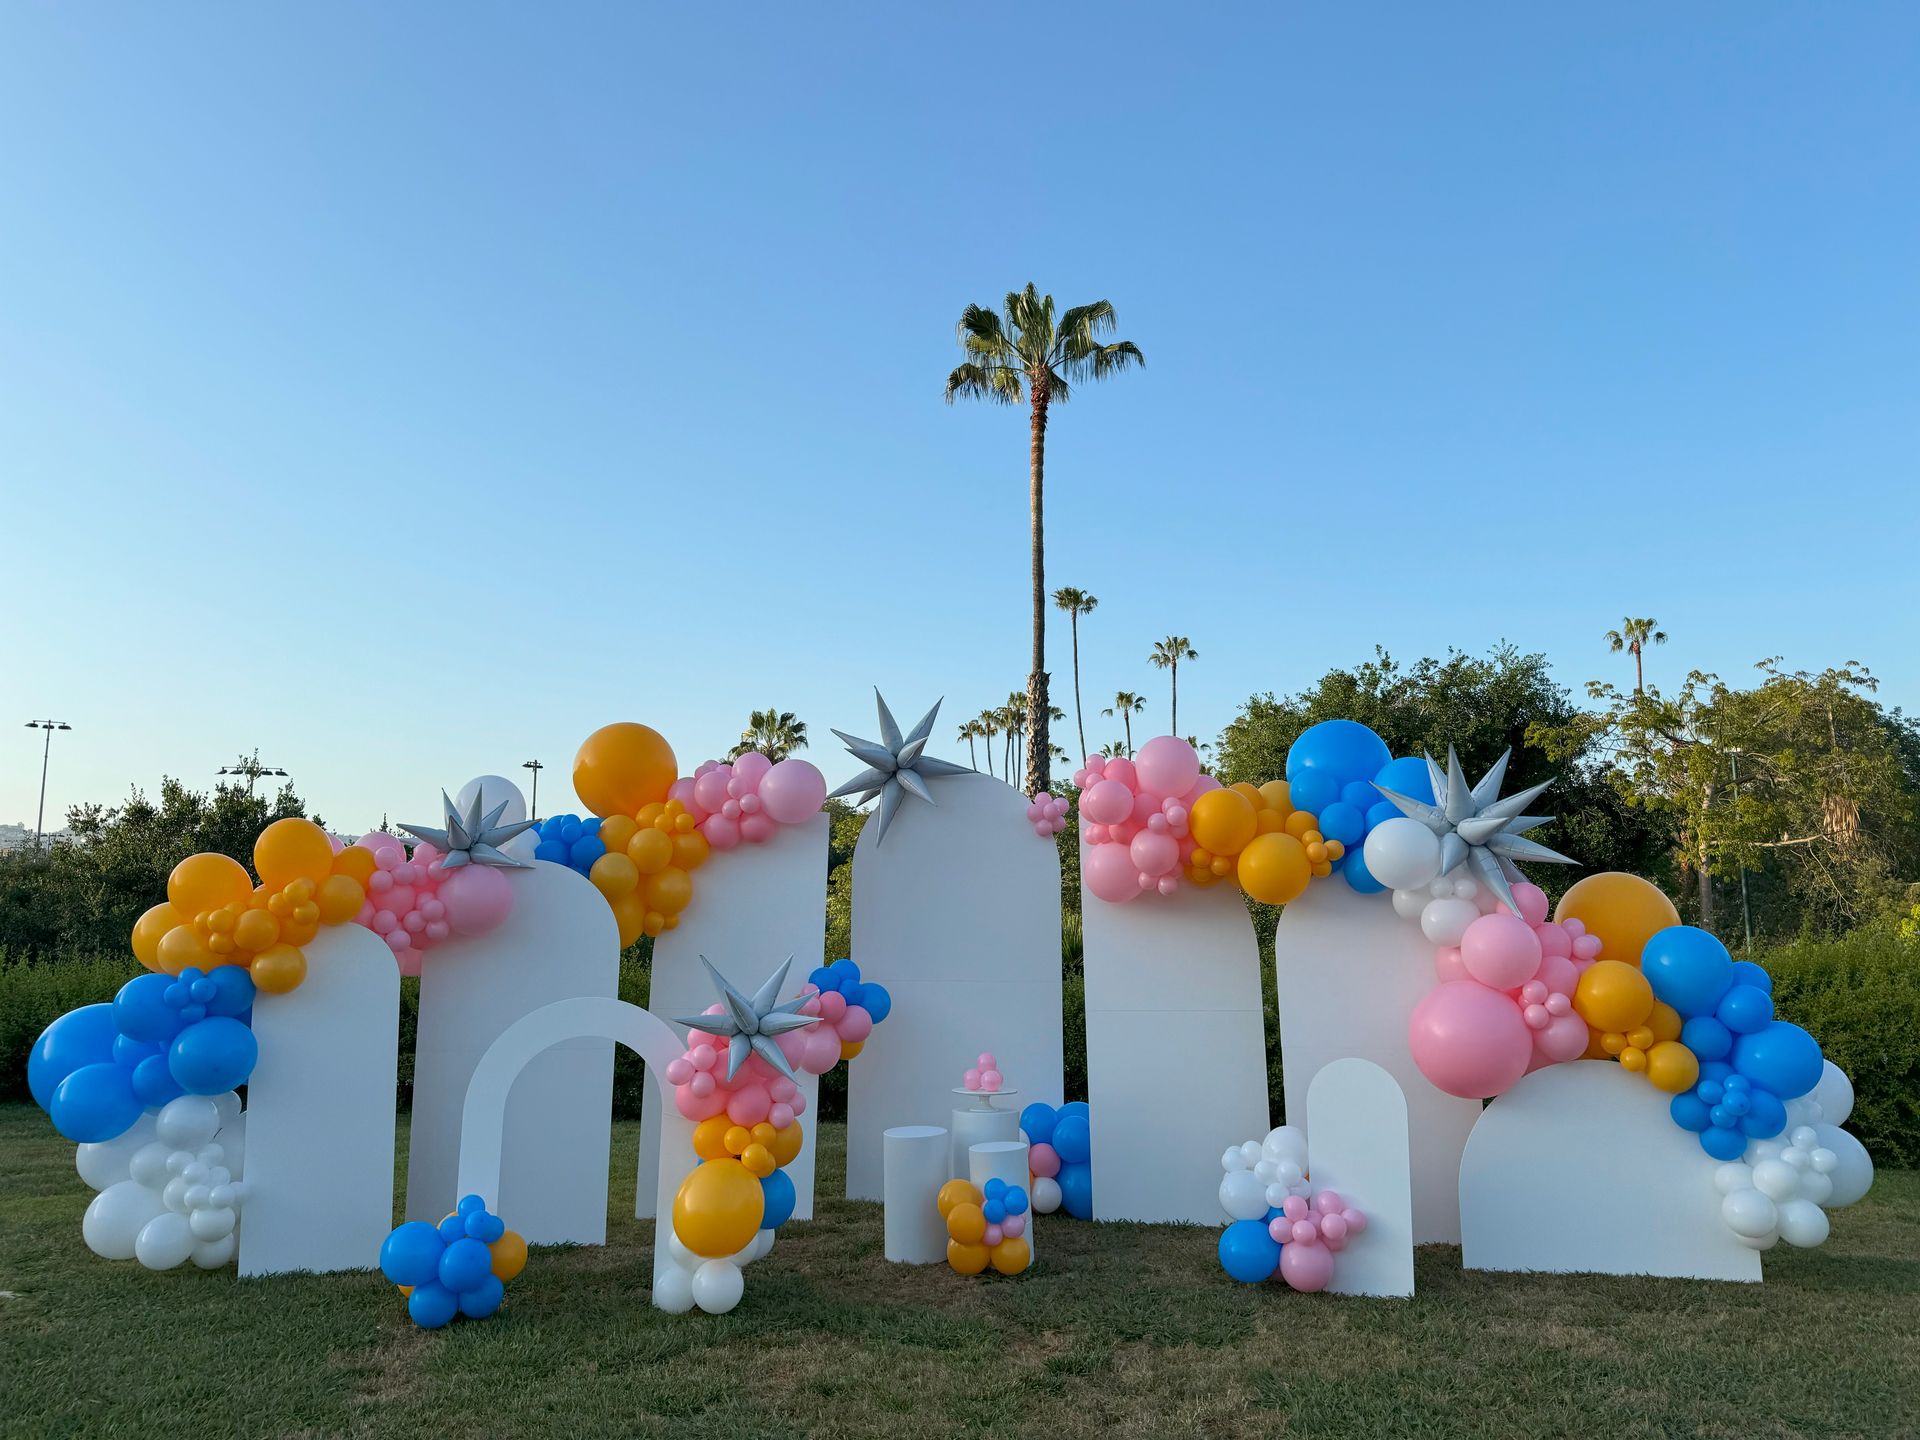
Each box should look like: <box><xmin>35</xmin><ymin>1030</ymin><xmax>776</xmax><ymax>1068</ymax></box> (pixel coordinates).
<box><xmin>947</xmin><ymin>284</ymin><xmax>1146</xmax><ymax>795</ymax></box>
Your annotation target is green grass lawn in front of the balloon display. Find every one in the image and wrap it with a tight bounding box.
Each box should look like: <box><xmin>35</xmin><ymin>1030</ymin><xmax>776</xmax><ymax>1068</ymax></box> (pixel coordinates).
<box><xmin>0</xmin><ymin>1106</ymin><xmax>1920</xmax><ymax>1440</ymax></box>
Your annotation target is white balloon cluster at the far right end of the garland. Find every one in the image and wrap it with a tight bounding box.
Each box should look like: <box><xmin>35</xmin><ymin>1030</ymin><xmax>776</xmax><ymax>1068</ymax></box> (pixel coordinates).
<box><xmin>1713</xmin><ymin>1060</ymin><xmax>1874</xmax><ymax>1250</ymax></box>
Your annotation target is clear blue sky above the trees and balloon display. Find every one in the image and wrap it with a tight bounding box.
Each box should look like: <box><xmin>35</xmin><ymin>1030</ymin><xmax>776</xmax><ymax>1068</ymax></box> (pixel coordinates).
<box><xmin>0</xmin><ymin>0</ymin><xmax>1920</xmax><ymax>828</ymax></box>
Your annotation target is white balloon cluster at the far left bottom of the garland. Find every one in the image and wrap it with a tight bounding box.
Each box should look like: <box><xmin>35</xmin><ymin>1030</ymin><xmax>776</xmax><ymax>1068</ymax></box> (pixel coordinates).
<box><xmin>75</xmin><ymin>1091</ymin><xmax>246</xmax><ymax>1269</ymax></box>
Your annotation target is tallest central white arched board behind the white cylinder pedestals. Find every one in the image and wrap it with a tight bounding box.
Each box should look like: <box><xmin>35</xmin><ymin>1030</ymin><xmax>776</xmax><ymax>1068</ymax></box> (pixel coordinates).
<box><xmin>847</xmin><ymin>774</ymin><xmax>1062</xmax><ymax>1200</ymax></box>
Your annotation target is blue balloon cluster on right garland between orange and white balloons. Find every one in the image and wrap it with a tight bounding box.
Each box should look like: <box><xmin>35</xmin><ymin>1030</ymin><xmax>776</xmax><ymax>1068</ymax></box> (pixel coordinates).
<box><xmin>1640</xmin><ymin>925</ymin><xmax>1824</xmax><ymax>1160</ymax></box>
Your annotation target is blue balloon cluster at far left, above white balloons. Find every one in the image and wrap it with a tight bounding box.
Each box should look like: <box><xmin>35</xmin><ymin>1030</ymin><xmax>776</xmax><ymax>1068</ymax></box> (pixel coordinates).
<box><xmin>27</xmin><ymin>966</ymin><xmax>259</xmax><ymax>1144</ymax></box>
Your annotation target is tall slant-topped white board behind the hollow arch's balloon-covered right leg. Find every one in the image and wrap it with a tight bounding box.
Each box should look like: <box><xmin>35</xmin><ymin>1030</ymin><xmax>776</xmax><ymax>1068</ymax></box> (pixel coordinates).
<box><xmin>634</xmin><ymin>812</ymin><xmax>833</xmax><ymax>1219</ymax></box>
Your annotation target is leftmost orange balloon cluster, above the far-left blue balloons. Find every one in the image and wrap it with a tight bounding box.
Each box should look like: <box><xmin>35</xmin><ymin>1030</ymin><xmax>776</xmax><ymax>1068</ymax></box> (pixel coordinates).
<box><xmin>132</xmin><ymin>816</ymin><xmax>374</xmax><ymax>995</ymax></box>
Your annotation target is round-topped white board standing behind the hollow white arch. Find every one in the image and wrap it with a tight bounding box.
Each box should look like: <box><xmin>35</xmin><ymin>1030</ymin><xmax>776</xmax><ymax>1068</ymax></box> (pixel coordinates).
<box><xmin>407</xmin><ymin>860</ymin><xmax>620</xmax><ymax>1244</ymax></box>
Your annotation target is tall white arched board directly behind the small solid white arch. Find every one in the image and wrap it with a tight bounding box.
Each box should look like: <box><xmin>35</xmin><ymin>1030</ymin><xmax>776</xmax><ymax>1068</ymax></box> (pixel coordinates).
<box><xmin>1273</xmin><ymin>876</ymin><xmax>1480</xmax><ymax>1244</ymax></box>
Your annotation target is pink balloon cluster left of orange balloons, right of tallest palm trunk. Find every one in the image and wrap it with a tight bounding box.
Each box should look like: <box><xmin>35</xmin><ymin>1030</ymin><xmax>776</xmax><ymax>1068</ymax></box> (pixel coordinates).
<box><xmin>1073</xmin><ymin>735</ymin><xmax>1219</xmax><ymax>902</ymax></box>
